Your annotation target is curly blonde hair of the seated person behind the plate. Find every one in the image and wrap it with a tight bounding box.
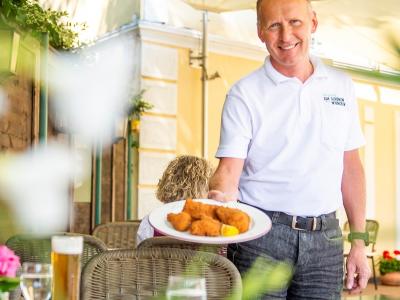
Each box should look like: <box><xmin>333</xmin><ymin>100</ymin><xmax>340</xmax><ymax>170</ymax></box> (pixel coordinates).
<box><xmin>157</xmin><ymin>155</ymin><xmax>213</xmax><ymax>203</ymax></box>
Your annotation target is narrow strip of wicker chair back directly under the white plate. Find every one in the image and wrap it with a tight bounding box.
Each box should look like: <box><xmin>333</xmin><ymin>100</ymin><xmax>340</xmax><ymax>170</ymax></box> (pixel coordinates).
<box><xmin>138</xmin><ymin>236</ymin><xmax>226</xmax><ymax>257</ymax></box>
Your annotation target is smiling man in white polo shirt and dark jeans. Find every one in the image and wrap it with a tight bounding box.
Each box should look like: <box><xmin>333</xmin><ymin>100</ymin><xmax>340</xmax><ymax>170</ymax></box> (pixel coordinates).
<box><xmin>209</xmin><ymin>0</ymin><xmax>370</xmax><ymax>299</ymax></box>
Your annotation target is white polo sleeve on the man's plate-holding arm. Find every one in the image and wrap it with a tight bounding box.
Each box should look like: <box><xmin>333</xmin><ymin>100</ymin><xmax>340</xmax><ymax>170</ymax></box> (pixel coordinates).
<box><xmin>215</xmin><ymin>91</ymin><xmax>252</xmax><ymax>159</ymax></box>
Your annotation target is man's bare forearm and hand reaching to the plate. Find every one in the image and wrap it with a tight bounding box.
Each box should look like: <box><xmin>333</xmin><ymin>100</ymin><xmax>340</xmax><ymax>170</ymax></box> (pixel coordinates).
<box><xmin>208</xmin><ymin>157</ymin><xmax>244</xmax><ymax>201</ymax></box>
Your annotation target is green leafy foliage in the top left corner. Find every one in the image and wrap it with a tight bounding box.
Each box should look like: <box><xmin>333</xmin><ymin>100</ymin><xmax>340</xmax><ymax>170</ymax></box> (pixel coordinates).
<box><xmin>0</xmin><ymin>0</ymin><xmax>86</xmax><ymax>50</ymax></box>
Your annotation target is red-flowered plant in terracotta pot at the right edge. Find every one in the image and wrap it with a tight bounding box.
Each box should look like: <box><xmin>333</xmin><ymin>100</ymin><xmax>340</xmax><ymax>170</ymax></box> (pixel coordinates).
<box><xmin>379</xmin><ymin>250</ymin><xmax>400</xmax><ymax>285</ymax></box>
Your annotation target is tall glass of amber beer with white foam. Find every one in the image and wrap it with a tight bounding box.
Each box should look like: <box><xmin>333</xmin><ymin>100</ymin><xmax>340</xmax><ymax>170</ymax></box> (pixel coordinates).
<box><xmin>51</xmin><ymin>236</ymin><xmax>83</xmax><ymax>300</ymax></box>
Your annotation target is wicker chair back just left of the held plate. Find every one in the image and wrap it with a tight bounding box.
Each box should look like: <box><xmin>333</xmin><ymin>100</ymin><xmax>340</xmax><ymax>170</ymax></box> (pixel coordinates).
<box><xmin>92</xmin><ymin>220</ymin><xmax>140</xmax><ymax>249</ymax></box>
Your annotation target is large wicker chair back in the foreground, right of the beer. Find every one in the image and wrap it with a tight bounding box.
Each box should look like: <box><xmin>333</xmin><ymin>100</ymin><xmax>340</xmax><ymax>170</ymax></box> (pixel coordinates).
<box><xmin>80</xmin><ymin>248</ymin><xmax>242</xmax><ymax>300</ymax></box>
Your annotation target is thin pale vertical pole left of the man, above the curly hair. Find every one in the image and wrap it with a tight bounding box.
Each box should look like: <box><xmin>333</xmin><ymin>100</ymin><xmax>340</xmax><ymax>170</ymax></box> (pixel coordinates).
<box><xmin>201</xmin><ymin>10</ymin><xmax>208</xmax><ymax>159</ymax></box>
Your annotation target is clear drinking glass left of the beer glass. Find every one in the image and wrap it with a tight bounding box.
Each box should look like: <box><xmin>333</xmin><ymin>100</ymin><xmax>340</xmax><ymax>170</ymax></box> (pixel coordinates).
<box><xmin>20</xmin><ymin>262</ymin><xmax>52</xmax><ymax>300</ymax></box>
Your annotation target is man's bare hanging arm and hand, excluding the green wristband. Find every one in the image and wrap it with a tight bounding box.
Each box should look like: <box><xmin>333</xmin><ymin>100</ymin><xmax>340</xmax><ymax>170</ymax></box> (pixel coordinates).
<box><xmin>342</xmin><ymin>149</ymin><xmax>371</xmax><ymax>293</ymax></box>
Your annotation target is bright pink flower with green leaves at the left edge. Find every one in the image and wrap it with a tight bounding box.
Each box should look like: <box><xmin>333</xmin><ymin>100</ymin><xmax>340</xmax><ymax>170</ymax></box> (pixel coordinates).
<box><xmin>0</xmin><ymin>245</ymin><xmax>20</xmax><ymax>300</ymax></box>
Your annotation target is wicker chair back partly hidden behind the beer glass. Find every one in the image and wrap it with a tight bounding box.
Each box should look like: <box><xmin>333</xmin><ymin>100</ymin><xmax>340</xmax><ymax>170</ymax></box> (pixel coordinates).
<box><xmin>6</xmin><ymin>232</ymin><xmax>107</xmax><ymax>268</ymax></box>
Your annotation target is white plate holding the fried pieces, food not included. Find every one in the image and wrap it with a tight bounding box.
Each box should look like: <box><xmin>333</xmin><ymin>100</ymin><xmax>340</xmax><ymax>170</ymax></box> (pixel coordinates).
<box><xmin>149</xmin><ymin>199</ymin><xmax>271</xmax><ymax>244</ymax></box>
